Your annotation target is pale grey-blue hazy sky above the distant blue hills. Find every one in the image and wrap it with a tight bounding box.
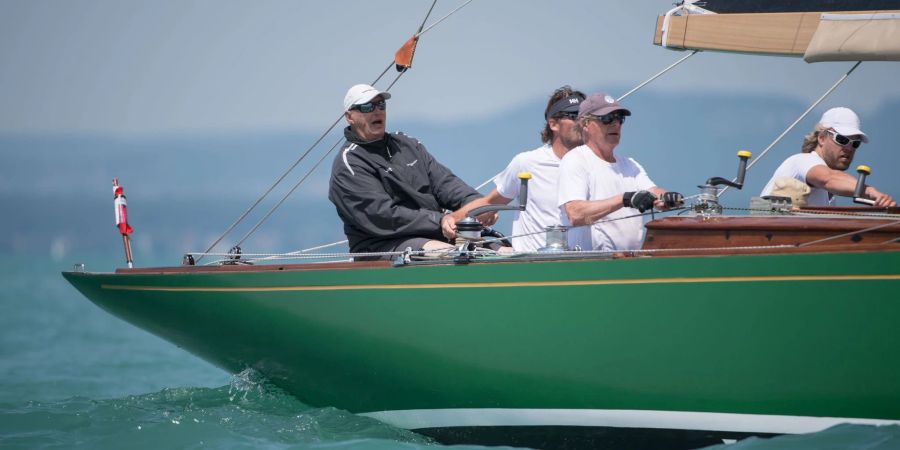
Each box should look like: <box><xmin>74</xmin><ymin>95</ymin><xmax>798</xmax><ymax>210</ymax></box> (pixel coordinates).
<box><xmin>0</xmin><ymin>0</ymin><xmax>900</xmax><ymax>135</ymax></box>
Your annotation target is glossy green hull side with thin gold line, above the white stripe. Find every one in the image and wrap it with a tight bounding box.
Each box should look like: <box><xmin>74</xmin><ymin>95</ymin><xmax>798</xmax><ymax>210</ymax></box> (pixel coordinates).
<box><xmin>64</xmin><ymin>251</ymin><xmax>900</xmax><ymax>444</ymax></box>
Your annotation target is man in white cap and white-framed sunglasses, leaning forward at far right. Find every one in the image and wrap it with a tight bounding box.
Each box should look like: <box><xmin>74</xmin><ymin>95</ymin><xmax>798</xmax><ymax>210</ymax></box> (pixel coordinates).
<box><xmin>760</xmin><ymin>107</ymin><xmax>896</xmax><ymax>207</ymax></box>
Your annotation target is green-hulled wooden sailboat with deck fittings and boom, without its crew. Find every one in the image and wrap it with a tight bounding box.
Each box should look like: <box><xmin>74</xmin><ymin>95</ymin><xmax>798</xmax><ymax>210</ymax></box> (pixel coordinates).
<box><xmin>63</xmin><ymin>0</ymin><xmax>900</xmax><ymax>448</ymax></box>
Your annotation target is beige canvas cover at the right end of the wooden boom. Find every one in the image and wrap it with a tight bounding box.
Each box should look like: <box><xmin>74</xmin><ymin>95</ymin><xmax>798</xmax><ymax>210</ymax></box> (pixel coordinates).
<box><xmin>803</xmin><ymin>13</ymin><xmax>900</xmax><ymax>63</ymax></box>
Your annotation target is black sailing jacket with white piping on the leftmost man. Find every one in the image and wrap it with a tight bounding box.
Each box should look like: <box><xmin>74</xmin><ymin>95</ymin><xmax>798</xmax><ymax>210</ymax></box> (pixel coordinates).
<box><xmin>328</xmin><ymin>127</ymin><xmax>481</xmax><ymax>253</ymax></box>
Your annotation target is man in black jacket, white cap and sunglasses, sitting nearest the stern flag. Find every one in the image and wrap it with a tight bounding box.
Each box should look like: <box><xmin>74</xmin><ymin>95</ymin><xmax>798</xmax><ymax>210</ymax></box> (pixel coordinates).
<box><xmin>328</xmin><ymin>84</ymin><xmax>481</xmax><ymax>259</ymax></box>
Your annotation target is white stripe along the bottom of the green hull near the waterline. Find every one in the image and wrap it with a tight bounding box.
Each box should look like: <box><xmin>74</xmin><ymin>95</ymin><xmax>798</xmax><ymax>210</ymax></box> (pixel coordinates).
<box><xmin>360</xmin><ymin>408</ymin><xmax>900</xmax><ymax>434</ymax></box>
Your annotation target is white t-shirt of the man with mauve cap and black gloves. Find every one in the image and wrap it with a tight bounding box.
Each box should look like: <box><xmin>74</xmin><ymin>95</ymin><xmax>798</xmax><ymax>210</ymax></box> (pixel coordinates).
<box><xmin>557</xmin><ymin>145</ymin><xmax>656</xmax><ymax>251</ymax></box>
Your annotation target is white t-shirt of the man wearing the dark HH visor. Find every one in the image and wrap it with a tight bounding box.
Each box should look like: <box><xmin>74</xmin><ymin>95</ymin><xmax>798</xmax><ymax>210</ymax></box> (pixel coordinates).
<box><xmin>494</xmin><ymin>144</ymin><xmax>562</xmax><ymax>252</ymax></box>
